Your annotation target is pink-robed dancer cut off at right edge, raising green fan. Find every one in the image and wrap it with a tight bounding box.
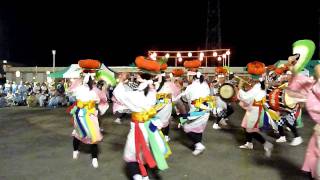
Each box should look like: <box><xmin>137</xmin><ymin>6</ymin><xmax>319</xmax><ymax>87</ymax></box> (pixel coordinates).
<box><xmin>280</xmin><ymin>40</ymin><xmax>320</xmax><ymax>179</ymax></box>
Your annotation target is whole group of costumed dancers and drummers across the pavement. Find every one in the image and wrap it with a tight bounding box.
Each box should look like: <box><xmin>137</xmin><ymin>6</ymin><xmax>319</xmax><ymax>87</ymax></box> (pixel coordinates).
<box><xmin>69</xmin><ymin>40</ymin><xmax>320</xmax><ymax>180</ymax></box>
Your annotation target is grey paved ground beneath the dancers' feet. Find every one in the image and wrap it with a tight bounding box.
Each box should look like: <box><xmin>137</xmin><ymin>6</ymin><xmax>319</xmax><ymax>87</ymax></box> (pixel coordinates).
<box><xmin>0</xmin><ymin>107</ymin><xmax>313</xmax><ymax>180</ymax></box>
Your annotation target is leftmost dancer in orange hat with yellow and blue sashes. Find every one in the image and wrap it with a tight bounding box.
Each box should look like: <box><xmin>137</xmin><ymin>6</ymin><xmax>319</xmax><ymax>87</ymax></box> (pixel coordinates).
<box><xmin>69</xmin><ymin>59</ymin><xmax>108</xmax><ymax>168</ymax></box>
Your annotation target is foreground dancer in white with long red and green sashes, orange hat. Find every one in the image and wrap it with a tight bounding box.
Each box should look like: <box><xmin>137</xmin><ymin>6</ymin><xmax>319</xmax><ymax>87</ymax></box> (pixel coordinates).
<box><xmin>113</xmin><ymin>56</ymin><xmax>171</xmax><ymax>180</ymax></box>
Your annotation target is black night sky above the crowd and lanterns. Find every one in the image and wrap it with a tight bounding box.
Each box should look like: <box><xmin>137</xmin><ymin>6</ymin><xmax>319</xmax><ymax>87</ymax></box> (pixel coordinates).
<box><xmin>0</xmin><ymin>0</ymin><xmax>319</xmax><ymax>66</ymax></box>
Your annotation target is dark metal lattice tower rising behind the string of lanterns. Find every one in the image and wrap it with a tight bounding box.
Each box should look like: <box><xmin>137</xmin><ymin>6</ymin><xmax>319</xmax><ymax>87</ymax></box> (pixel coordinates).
<box><xmin>206</xmin><ymin>0</ymin><xmax>221</xmax><ymax>49</ymax></box>
